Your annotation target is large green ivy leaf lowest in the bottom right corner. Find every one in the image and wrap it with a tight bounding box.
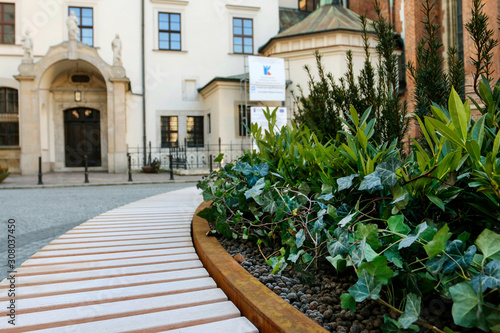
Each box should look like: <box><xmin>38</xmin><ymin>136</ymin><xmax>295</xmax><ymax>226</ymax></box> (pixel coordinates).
<box><xmin>450</xmin><ymin>282</ymin><xmax>488</xmax><ymax>331</ymax></box>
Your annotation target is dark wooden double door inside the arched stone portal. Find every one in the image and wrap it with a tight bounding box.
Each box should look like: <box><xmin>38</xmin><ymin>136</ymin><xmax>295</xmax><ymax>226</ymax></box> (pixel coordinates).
<box><xmin>64</xmin><ymin>108</ymin><xmax>101</xmax><ymax>167</ymax></box>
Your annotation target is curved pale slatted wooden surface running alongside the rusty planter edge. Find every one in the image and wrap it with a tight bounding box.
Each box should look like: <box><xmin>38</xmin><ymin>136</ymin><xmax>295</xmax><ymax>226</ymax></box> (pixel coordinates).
<box><xmin>0</xmin><ymin>188</ymin><xmax>257</xmax><ymax>333</ymax></box>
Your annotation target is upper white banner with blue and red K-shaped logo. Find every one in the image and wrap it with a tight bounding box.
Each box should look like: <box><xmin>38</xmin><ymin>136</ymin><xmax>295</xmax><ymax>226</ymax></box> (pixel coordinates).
<box><xmin>248</xmin><ymin>56</ymin><xmax>286</xmax><ymax>101</ymax></box>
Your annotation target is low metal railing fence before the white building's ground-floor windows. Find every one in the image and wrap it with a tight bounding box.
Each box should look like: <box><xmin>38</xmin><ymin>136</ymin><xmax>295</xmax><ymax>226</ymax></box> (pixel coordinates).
<box><xmin>128</xmin><ymin>143</ymin><xmax>252</xmax><ymax>170</ymax></box>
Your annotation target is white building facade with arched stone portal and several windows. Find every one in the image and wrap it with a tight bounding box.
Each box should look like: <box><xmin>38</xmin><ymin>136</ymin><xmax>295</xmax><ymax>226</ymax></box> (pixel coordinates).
<box><xmin>0</xmin><ymin>0</ymin><xmax>376</xmax><ymax>174</ymax></box>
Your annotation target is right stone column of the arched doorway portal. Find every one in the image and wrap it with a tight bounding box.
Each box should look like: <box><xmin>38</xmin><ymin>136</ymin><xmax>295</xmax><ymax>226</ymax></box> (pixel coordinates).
<box><xmin>108</xmin><ymin>78</ymin><xmax>129</xmax><ymax>173</ymax></box>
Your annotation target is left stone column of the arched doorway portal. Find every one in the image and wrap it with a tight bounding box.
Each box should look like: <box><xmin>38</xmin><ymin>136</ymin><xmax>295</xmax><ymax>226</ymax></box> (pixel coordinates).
<box><xmin>15</xmin><ymin>74</ymin><xmax>41</xmax><ymax>175</ymax></box>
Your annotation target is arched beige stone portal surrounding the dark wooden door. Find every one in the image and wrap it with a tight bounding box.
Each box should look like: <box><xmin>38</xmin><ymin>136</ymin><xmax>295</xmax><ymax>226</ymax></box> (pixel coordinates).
<box><xmin>15</xmin><ymin>40</ymin><xmax>129</xmax><ymax>175</ymax></box>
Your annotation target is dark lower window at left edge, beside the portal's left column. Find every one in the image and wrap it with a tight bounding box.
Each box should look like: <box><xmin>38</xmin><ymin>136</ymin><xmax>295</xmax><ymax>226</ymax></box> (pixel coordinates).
<box><xmin>0</xmin><ymin>88</ymin><xmax>19</xmax><ymax>146</ymax></box>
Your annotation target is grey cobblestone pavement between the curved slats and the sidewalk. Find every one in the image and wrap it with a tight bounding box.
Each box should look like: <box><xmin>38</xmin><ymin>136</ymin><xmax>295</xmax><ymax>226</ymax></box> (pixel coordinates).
<box><xmin>0</xmin><ymin>182</ymin><xmax>201</xmax><ymax>281</ymax></box>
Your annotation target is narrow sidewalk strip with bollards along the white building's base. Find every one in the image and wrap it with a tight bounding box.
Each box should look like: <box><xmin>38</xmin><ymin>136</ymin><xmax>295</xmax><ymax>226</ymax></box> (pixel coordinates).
<box><xmin>0</xmin><ymin>172</ymin><xmax>202</xmax><ymax>190</ymax></box>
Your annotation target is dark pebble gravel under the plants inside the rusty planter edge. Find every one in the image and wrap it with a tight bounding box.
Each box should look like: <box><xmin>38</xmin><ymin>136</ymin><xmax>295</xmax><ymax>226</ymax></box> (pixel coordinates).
<box><xmin>218</xmin><ymin>236</ymin><xmax>474</xmax><ymax>333</ymax></box>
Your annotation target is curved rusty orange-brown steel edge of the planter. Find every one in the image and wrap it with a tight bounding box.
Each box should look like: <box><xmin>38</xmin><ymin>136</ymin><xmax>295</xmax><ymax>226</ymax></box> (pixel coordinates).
<box><xmin>192</xmin><ymin>202</ymin><xmax>328</xmax><ymax>333</ymax></box>
